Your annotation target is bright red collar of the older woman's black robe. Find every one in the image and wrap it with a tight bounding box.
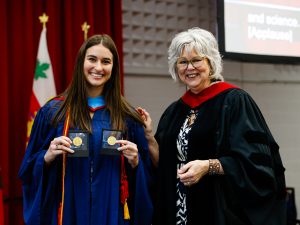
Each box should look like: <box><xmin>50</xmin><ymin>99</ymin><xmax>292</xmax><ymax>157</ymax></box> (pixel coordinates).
<box><xmin>181</xmin><ymin>82</ymin><xmax>238</xmax><ymax>108</ymax></box>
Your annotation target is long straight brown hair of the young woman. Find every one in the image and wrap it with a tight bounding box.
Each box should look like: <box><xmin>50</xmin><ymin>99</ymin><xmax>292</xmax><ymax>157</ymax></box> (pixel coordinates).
<box><xmin>52</xmin><ymin>34</ymin><xmax>143</xmax><ymax>132</ymax></box>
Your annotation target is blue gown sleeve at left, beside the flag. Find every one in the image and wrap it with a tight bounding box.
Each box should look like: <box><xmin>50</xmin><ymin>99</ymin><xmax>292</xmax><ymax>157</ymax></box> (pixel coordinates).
<box><xmin>18</xmin><ymin>102</ymin><xmax>61</xmax><ymax>225</ymax></box>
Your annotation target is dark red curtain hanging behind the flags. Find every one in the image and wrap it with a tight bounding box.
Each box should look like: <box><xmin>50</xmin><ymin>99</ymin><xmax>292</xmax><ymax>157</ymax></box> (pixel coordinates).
<box><xmin>0</xmin><ymin>0</ymin><xmax>123</xmax><ymax>225</ymax></box>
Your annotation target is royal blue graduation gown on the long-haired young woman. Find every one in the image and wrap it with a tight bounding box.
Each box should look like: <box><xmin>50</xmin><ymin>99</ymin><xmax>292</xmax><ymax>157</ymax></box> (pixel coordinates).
<box><xmin>19</xmin><ymin>100</ymin><xmax>153</xmax><ymax>225</ymax></box>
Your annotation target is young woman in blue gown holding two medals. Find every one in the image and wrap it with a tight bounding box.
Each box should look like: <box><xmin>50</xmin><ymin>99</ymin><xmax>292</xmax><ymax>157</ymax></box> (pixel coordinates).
<box><xmin>19</xmin><ymin>35</ymin><xmax>152</xmax><ymax>225</ymax></box>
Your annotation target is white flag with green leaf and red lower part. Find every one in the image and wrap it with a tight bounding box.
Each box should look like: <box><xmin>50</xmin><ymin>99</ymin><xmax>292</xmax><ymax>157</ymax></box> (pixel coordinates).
<box><xmin>27</xmin><ymin>27</ymin><xmax>56</xmax><ymax>142</ymax></box>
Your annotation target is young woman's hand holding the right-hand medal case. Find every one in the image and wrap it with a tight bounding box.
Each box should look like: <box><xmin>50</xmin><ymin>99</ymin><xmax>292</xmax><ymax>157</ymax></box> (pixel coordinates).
<box><xmin>116</xmin><ymin>140</ymin><xmax>139</xmax><ymax>168</ymax></box>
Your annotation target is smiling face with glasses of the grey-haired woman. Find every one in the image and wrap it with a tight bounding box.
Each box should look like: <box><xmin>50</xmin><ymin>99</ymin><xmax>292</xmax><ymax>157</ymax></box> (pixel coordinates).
<box><xmin>177</xmin><ymin>48</ymin><xmax>211</xmax><ymax>94</ymax></box>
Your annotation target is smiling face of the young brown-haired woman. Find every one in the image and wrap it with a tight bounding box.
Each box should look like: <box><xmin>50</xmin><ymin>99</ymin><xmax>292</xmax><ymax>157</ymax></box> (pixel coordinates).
<box><xmin>83</xmin><ymin>44</ymin><xmax>113</xmax><ymax>97</ymax></box>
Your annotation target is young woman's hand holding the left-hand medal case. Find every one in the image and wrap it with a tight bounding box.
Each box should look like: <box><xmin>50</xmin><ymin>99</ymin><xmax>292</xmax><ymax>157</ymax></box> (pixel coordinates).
<box><xmin>44</xmin><ymin>136</ymin><xmax>74</xmax><ymax>164</ymax></box>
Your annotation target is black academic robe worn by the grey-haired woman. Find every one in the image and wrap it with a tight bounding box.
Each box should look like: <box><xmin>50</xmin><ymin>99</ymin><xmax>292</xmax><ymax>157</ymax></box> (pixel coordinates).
<box><xmin>154</xmin><ymin>82</ymin><xmax>286</xmax><ymax>225</ymax></box>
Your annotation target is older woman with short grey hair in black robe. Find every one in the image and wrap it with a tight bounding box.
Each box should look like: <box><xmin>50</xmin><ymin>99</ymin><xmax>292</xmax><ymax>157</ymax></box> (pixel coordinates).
<box><xmin>140</xmin><ymin>28</ymin><xmax>285</xmax><ymax>225</ymax></box>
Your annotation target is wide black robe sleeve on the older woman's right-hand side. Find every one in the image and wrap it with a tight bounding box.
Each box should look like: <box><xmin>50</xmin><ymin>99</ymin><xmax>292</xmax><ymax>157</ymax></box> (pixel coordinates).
<box><xmin>218</xmin><ymin>89</ymin><xmax>286</xmax><ymax>225</ymax></box>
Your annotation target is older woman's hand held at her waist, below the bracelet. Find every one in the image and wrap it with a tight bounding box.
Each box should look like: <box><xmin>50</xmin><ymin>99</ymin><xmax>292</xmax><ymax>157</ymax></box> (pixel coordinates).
<box><xmin>177</xmin><ymin>160</ymin><xmax>209</xmax><ymax>186</ymax></box>
